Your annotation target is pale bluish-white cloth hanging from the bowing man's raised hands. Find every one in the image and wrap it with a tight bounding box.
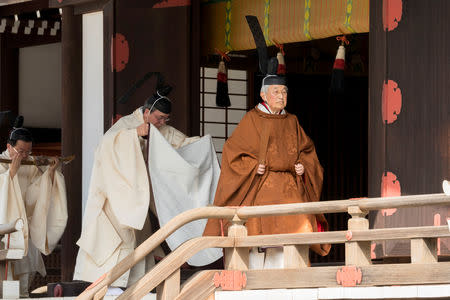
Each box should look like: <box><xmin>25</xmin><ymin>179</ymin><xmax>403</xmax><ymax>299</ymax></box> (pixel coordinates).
<box><xmin>148</xmin><ymin>125</ymin><xmax>222</xmax><ymax>266</ymax></box>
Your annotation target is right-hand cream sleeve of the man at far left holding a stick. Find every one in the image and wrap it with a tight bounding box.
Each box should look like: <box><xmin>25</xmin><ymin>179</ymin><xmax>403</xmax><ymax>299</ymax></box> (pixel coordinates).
<box><xmin>25</xmin><ymin>168</ymin><xmax>67</xmax><ymax>255</ymax></box>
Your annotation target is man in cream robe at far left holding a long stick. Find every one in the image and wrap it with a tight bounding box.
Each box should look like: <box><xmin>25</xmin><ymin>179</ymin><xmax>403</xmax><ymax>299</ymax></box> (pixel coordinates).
<box><xmin>0</xmin><ymin>128</ymin><xmax>67</xmax><ymax>297</ymax></box>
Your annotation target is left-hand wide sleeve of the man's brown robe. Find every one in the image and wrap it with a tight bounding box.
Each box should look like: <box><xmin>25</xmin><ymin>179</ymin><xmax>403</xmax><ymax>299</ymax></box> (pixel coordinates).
<box><xmin>203</xmin><ymin>112</ymin><xmax>267</xmax><ymax>235</ymax></box>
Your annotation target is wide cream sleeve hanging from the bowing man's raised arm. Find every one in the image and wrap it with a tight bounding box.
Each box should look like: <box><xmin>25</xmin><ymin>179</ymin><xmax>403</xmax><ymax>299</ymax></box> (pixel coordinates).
<box><xmin>97</xmin><ymin>128</ymin><xmax>150</xmax><ymax>230</ymax></box>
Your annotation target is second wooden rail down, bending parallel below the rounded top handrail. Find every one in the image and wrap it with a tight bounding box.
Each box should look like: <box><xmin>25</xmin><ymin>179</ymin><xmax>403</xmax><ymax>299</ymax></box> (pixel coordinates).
<box><xmin>117</xmin><ymin>226</ymin><xmax>450</xmax><ymax>300</ymax></box>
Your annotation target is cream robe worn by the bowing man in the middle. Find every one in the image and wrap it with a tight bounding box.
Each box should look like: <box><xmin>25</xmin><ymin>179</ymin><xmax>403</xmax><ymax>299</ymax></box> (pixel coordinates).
<box><xmin>74</xmin><ymin>108</ymin><xmax>220</xmax><ymax>287</ymax></box>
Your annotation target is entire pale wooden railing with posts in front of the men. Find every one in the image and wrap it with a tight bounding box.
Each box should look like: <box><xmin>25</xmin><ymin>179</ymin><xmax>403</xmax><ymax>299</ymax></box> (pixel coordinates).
<box><xmin>77</xmin><ymin>194</ymin><xmax>450</xmax><ymax>300</ymax></box>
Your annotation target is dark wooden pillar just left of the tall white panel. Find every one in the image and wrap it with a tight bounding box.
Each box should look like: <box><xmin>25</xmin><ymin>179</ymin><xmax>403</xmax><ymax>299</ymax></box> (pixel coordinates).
<box><xmin>61</xmin><ymin>7</ymin><xmax>82</xmax><ymax>281</ymax></box>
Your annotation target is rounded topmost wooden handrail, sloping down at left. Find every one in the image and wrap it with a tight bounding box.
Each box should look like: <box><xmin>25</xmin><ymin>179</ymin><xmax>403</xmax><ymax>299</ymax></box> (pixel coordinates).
<box><xmin>76</xmin><ymin>193</ymin><xmax>450</xmax><ymax>300</ymax></box>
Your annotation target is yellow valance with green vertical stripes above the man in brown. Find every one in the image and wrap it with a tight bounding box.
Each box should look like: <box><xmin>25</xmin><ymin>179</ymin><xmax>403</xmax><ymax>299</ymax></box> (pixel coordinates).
<box><xmin>202</xmin><ymin>0</ymin><xmax>369</xmax><ymax>53</ymax></box>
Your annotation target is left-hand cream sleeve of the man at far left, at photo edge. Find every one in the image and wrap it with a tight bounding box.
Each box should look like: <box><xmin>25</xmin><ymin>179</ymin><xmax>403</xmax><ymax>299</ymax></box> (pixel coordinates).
<box><xmin>0</xmin><ymin>167</ymin><xmax>28</xmax><ymax>255</ymax></box>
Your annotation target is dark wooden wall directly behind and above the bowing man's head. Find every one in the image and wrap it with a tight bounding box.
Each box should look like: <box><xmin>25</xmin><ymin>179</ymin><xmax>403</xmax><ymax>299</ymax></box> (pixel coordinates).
<box><xmin>109</xmin><ymin>0</ymin><xmax>200</xmax><ymax>135</ymax></box>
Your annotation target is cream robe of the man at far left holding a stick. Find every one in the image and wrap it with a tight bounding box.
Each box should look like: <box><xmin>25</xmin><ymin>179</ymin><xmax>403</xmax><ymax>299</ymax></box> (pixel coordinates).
<box><xmin>0</xmin><ymin>150</ymin><xmax>67</xmax><ymax>277</ymax></box>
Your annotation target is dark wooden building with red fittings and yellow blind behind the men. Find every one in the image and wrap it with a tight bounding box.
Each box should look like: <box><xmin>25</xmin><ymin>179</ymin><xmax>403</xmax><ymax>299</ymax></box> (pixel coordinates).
<box><xmin>0</xmin><ymin>0</ymin><xmax>450</xmax><ymax>292</ymax></box>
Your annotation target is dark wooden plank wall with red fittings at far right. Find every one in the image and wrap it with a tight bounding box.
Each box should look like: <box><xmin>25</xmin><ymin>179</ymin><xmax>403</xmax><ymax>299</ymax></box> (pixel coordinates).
<box><xmin>369</xmin><ymin>0</ymin><xmax>450</xmax><ymax>257</ymax></box>
